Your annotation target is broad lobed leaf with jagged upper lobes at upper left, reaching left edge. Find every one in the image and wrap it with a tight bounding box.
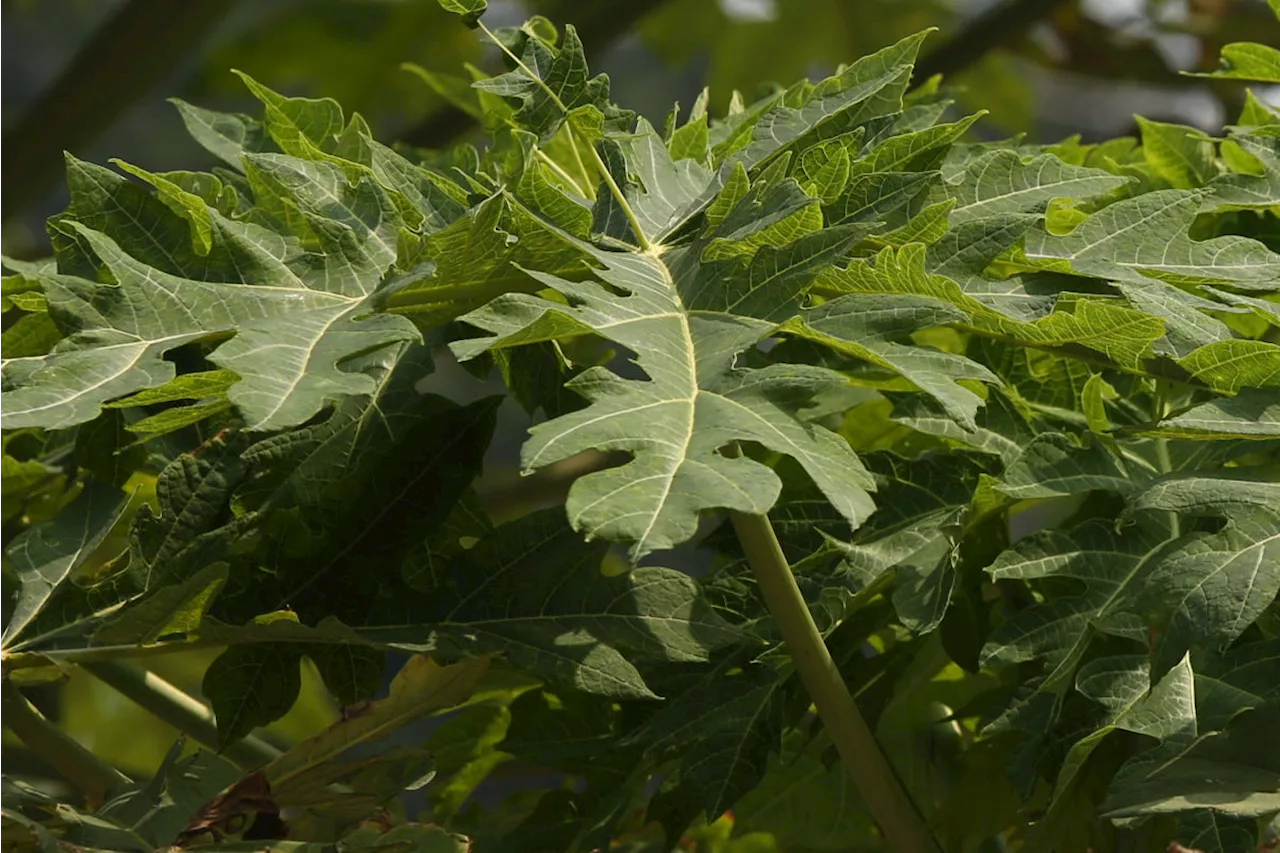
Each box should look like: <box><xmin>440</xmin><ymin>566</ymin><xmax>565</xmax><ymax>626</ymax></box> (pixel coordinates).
<box><xmin>0</xmin><ymin>72</ymin><xmax>488</xmax><ymax>430</ymax></box>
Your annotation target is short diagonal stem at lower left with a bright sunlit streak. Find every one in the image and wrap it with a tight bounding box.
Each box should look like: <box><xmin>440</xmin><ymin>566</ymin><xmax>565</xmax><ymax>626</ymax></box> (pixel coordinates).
<box><xmin>83</xmin><ymin>661</ymin><xmax>280</xmax><ymax>770</ymax></box>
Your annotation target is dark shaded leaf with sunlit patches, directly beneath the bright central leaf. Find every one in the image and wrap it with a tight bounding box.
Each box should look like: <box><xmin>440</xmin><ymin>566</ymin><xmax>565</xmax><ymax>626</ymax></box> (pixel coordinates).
<box><xmin>362</xmin><ymin>510</ymin><xmax>742</xmax><ymax>698</ymax></box>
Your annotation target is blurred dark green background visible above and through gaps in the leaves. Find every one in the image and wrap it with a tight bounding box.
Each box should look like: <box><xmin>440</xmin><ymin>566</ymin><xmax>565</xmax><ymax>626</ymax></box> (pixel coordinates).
<box><xmin>0</xmin><ymin>0</ymin><xmax>1280</xmax><ymax>819</ymax></box>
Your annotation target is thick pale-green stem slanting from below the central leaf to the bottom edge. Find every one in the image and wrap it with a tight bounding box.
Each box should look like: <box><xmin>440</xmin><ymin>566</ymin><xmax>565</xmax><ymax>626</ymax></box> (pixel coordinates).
<box><xmin>731</xmin><ymin>448</ymin><xmax>938</xmax><ymax>853</ymax></box>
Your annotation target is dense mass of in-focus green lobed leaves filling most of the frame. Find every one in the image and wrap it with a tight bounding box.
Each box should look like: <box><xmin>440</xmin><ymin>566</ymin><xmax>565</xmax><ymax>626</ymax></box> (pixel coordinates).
<box><xmin>0</xmin><ymin>0</ymin><xmax>1280</xmax><ymax>853</ymax></box>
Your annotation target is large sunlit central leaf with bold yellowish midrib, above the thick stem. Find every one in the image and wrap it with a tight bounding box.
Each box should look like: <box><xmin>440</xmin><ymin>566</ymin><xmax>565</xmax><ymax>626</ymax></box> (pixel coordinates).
<box><xmin>454</xmin><ymin>220</ymin><xmax>872</xmax><ymax>558</ymax></box>
